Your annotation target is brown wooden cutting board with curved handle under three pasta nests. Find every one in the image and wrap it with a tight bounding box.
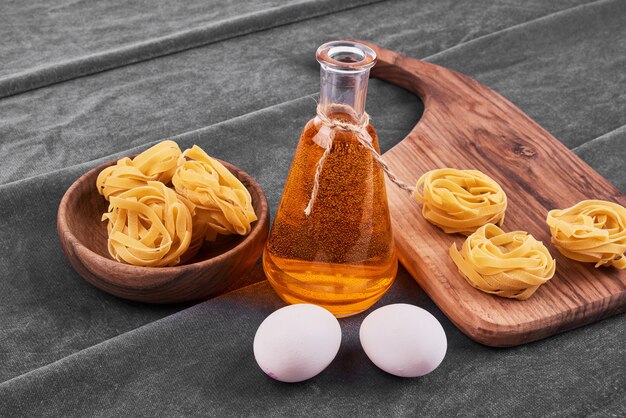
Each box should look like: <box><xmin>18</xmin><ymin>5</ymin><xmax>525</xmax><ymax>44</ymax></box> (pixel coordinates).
<box><xmin>359</xmin><ymin>41</ymin><xmax>626</xmax><ymax>347</ymax></box>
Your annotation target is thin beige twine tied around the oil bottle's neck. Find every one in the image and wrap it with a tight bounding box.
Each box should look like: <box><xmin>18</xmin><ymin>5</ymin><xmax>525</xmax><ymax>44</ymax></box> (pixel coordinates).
<box><xmin>304</xmin><ymin>105</ymin><xmax>415</xmax><ymax>216</ymax></box>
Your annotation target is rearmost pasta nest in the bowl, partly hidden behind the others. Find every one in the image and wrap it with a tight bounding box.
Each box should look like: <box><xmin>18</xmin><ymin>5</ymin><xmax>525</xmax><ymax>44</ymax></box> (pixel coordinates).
<box><xmin>96</xmin><ymin>141</ymin><xmax>181</xmax><ymax>200</ymax></box>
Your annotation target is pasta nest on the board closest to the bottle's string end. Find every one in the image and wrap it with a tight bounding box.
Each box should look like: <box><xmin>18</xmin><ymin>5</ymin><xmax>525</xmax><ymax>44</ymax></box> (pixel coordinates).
<box><xmin>415</xmin><ymin>168</ymin><xmax>507</xmax><ymax>235</ymax></box>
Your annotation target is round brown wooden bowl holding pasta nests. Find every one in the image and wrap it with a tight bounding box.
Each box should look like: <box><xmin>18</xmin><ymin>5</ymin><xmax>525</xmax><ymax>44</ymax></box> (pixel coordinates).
<box><xmin>57</xmin><ymin>161</ymin><xmax>269</xmax><ymax>303</ymax></box>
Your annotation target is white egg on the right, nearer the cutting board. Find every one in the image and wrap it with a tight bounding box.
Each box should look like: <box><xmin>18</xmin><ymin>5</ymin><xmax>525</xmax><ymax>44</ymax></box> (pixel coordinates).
<box><xmin>359</xmin><ymin>303</ymin><xmax>448</xmax><ymax>377</ymax></box>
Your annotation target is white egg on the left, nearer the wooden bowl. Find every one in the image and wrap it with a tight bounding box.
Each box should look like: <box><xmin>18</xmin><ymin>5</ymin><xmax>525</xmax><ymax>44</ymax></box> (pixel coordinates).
<box><xmin>254</xmin><ymin>304</ymin><xmax>341</xmax><ymax>382</ymax></box>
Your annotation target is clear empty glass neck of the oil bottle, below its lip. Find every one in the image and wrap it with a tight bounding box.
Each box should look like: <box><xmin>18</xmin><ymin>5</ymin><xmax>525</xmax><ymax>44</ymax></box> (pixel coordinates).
<box><xmin>319</xmin><ymin>63</ymin><xmax>370</xmax><ymax>123</ymax></box>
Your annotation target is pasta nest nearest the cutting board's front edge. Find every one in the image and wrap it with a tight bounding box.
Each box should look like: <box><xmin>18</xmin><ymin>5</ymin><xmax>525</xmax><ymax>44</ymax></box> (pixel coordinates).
<box><xmin>450</xmin><ymin>224</ymin><xmax>556</xmax><ymax>300</ymax></box>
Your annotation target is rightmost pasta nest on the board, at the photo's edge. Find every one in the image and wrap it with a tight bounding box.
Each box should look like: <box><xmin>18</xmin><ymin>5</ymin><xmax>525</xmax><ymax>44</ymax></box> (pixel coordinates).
<box><xmin>546</xmin><ymin>200</ymin><xmax>626</xmax><ymax>269</ymax></box>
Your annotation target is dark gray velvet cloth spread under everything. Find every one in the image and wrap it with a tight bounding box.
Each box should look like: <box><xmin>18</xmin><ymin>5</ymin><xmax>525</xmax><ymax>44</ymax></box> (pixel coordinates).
<box><xmin>0</xmin><ymin>0</ymin><xmax>626</xmax><ymax>417</ymax></box>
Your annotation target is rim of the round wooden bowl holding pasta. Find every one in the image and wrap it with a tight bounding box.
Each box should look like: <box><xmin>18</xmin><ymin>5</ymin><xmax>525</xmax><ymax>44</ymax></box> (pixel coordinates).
<box><xmin>57</xmin><ymin>155</ymin><xmax>269</xmax><ymax>287</ymax></box>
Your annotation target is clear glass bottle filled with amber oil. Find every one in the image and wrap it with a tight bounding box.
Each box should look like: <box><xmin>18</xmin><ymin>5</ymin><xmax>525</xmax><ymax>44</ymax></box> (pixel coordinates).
<box><xmin>263</xmin><ymin>41</ymin><xmax>397</xmax><ymax>317</ymax></box>
